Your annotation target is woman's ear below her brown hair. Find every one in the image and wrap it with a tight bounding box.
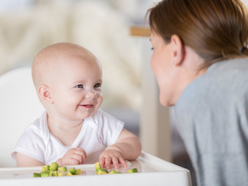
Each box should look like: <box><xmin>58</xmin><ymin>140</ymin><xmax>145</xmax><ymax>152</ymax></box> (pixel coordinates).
<box><xmin>171</xmin><ymin>35</ymin><xmax>184</xmax><ymax>66</ymax></box>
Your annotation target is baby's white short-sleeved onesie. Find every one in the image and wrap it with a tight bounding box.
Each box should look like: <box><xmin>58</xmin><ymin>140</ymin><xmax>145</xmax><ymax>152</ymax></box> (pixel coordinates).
<box><xmin>11</xmin><ymin>109</ymin><xmax>124</xmax><ymax>165</ymax></box>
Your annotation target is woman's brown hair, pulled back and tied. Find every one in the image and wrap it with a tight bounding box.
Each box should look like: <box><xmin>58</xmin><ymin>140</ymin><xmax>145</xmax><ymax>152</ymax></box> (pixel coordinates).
<box><xmin>147</xmin><ymin>0</ymin><xmax>248</xmax><ymax>62</ymax></box>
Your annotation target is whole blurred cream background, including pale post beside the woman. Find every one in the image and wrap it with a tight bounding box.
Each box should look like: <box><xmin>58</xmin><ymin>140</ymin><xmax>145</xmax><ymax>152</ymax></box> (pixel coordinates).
<box><xmin>0</xmin><ymin>0</ymin><xmax>248</xmax><ymax>185</ymax></box>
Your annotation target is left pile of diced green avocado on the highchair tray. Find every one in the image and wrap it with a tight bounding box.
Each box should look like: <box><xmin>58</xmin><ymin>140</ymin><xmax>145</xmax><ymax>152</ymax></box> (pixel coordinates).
<box><xmin>33</xmin><ymin>162</ymin><xmax>81</xmax><ymax>177</ymax></box>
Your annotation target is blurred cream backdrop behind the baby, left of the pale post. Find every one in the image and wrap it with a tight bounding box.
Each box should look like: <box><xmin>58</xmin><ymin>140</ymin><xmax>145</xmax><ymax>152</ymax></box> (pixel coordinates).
<box><xmin>0</xmin><ymin>0</ymin><xmax>159</xmax><ymax>135</ymax></box>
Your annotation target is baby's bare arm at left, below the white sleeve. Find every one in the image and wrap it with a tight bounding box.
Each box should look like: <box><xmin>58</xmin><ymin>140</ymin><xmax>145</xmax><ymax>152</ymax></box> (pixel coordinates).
<box><xmin>16</xmin><ymin>152</ymin><xmax>44</xmax><ymax>167</ymax></box>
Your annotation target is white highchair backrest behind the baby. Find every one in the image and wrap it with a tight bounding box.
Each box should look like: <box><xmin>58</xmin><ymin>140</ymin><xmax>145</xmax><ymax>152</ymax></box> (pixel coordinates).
<box><xmin>0</xmin><ymin>67</ymin><xmax>45</xmax><ymax>168</ymax></box>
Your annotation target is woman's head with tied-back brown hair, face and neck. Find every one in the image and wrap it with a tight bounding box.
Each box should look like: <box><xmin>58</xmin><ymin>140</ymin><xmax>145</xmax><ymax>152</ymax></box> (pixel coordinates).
<box><xmin>148</xmin><ymin>0</ymin><xmax>248</xmax><ymax>106</ymax></box>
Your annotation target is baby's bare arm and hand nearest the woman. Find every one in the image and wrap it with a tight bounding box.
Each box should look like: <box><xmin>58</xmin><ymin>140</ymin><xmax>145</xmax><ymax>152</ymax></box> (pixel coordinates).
<box><xmin>99</xmin><ymin>129</ymin><xmax>141</xmax><ymax>169</ymax></box>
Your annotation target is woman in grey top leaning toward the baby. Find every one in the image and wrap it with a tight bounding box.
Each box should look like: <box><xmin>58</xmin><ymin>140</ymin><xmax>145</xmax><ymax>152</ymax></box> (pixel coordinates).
<box><xmin>148</xmin><ymin>0</ymin><xmax>248</xmax><ymax>186</ymax></box>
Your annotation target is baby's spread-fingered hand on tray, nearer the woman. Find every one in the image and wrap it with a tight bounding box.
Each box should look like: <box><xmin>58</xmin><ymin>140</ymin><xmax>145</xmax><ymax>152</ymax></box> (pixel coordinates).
<box><xmin>99</xmin><ymin>149</ymin><xmax>127</xmax><ymax>169</ymax></box>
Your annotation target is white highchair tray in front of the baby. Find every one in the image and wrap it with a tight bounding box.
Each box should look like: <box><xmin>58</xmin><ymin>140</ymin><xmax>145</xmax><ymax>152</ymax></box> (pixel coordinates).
<box><xmin>0</xmin><ymin>152</ymin><xmax>191</xmax><ymax>186</ymax></box>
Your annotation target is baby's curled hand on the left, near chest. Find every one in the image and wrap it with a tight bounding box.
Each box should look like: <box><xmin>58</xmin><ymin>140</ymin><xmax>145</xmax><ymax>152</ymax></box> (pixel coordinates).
<box><xmin>61</xmin><ymin>147</ymin><xmax>87</xmax><ymax>165</ymax></box>
